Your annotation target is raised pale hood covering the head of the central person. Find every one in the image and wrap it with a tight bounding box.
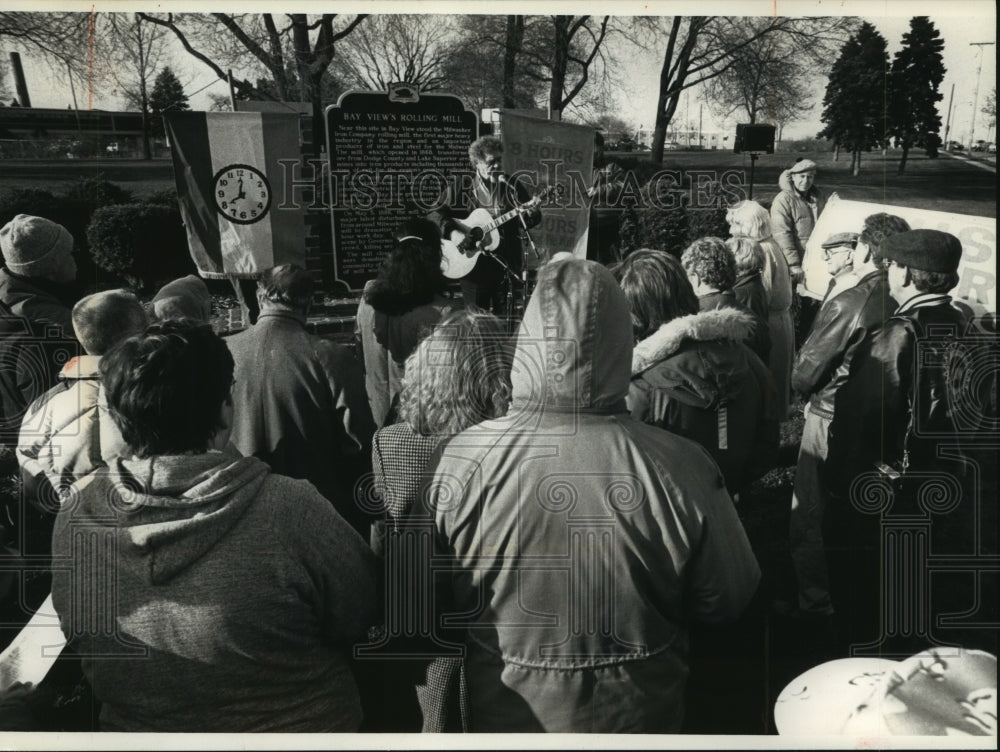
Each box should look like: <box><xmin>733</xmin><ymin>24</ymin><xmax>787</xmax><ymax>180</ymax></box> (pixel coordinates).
<box><xmin>511</xmin><ymin>259</ymin><xmax>632</xmax><ymax>413</ymax></box>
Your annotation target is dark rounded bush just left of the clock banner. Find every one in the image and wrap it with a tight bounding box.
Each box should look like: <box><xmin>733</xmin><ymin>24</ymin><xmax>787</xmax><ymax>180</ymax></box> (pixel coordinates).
<box><xmin>87</xmin><ymin>204</ymin><xmax>196</xmax><ymax>295</ymax></box>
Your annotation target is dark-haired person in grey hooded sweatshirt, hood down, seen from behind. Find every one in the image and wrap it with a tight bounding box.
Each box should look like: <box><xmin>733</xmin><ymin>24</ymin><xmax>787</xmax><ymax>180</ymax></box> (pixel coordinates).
<box><xmin>46</xmin><ymin>321</ymin><xmax>378</xmax><ymax>732</ymax></box>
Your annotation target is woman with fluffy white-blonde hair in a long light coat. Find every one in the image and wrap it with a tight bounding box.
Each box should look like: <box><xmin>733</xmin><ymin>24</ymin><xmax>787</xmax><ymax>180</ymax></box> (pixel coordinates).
<box><xmin>726</xmin><ymin>201</ymin><xmax>795</xmax><ymax>417</ymax></box>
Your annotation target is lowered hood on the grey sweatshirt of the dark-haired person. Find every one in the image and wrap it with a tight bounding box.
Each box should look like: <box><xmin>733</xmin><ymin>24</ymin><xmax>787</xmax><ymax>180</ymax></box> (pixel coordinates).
<box><xmin>83</xmin><ymin>447</ymin><xmax>270</xmax><ymax>585</ymax></box>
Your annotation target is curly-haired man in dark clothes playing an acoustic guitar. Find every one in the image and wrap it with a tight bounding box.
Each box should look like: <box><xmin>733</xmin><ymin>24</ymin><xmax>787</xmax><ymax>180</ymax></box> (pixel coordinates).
<box><xmin>428</xmin><ymin>136</ymin><xmax>542</xmax><ymax>315</ymax></box>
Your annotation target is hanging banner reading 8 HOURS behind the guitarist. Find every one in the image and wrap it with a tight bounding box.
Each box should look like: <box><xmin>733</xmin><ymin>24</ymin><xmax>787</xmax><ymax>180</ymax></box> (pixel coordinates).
<box><xmin>501</xmin><ymin>111</ymin><xmax>594</xmax><ymax>269</ymax></box>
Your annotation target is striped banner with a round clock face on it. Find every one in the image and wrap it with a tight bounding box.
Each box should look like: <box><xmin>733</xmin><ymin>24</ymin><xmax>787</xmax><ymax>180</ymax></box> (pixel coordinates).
<box><xmin>164</xmin><ymin>112</ymin><xmax>305</xmax><ymax>279</ymax></box>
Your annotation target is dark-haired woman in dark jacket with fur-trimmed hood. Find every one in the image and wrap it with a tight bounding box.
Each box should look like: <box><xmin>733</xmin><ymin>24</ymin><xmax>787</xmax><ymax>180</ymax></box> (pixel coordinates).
<box><xmin>615</xmin><ymin>248</ymin><xmax>779</xmax><ymax>494</ymax></box>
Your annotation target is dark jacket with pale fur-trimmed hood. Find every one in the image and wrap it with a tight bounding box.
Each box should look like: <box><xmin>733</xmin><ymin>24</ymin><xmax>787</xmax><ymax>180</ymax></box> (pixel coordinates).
<box><xmin>628</xmin><ymin>308</ymin><xmax>779</xmax><ymax>493</ymax></box>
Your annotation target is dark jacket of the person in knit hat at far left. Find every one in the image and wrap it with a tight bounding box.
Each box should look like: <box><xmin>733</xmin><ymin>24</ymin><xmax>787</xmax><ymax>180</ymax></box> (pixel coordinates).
<box><xmin>0</xmin><ymin>268</ymin><xmax>79</xmax><ymax>447</ymax></box>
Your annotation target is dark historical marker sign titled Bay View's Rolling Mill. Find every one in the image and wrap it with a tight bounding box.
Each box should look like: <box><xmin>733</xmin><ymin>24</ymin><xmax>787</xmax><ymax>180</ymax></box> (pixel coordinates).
<box><xmin>326</xmin><ymin>84</ymin><xmax>479</xmax><ymax>290</ymax></box>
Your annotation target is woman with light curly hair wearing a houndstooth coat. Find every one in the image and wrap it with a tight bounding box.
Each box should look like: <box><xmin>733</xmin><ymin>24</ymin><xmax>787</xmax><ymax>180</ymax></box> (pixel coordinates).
<box><xmin>364</xmin><ymin>309</ymin><xmax>512</xmax><ymax>732</ymax></box>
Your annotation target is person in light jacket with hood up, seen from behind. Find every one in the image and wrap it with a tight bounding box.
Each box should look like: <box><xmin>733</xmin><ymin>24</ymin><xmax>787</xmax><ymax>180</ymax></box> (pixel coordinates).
<box><xmin>411</xmin><ymin>259</ymin><xmax>760</xmax><ymax>733</ymax></box>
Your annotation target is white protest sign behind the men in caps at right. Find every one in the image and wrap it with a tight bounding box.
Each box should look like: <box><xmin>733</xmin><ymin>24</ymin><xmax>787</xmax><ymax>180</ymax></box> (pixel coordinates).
<box><xmin>802</xmin><ymin>197</ymin><xmax>997</xmax><ymax>313</ymax></box>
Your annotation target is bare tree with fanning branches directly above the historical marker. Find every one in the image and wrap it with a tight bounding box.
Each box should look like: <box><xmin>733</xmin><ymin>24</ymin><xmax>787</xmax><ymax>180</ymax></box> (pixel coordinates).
<box><xmin>335</xmin><ymin>14</ymin><xmax>453</xmax><ymax>91</ymax></box>
